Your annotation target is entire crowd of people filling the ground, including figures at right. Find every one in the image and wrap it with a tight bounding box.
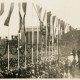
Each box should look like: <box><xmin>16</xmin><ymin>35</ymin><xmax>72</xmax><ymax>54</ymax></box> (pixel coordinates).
<box><xmin>0</xmin><ymin>39</ymin><xmax>80</xmax><ymax>78</ymax></box>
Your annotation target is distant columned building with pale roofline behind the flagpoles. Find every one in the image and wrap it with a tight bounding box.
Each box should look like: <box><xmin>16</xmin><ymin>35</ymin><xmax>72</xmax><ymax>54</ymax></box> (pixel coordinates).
<box><xmin>21</xmin><ymin>26</ymin><xmax>41</xmax><ymax>44</ymax></box>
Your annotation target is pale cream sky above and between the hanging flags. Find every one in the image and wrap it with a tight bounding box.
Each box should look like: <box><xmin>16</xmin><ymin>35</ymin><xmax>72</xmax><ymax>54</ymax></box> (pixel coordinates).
<box><xmin>0</xmin><ymin>0</ymin><xmax>80</xmax><ymax>37</ymax></box>
